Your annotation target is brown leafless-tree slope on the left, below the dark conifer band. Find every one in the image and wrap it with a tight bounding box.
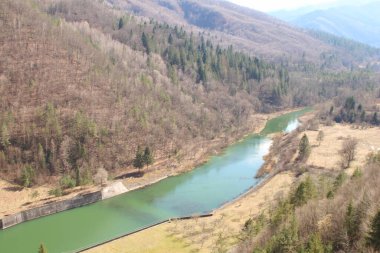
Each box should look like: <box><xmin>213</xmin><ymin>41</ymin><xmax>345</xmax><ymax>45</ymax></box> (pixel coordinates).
<box><xmin>0</xmin><ymin>1</ymin><xmax>290</xmax><ymax>185</ymax></box>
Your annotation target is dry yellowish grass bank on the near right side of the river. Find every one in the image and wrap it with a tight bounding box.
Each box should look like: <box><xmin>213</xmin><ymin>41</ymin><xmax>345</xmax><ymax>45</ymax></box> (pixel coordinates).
<box><xmin>85</xmin><ymin>109</ymin><xmax>312</xmax><ymax>253</ymax></box>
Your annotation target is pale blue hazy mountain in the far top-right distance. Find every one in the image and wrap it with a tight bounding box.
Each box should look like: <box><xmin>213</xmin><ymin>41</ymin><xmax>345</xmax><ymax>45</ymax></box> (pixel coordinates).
<box><xmin>272</xmin><ymin>1</ymin><xmax>380</xmax><ymax>47</ymax></box>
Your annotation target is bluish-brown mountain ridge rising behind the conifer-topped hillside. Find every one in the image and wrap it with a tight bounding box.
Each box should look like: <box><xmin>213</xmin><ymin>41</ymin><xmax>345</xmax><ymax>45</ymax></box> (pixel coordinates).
<box><xmin>107</xmin><ymin>0</ymin><xmax>332</xmax><ymax>61</ymax></box>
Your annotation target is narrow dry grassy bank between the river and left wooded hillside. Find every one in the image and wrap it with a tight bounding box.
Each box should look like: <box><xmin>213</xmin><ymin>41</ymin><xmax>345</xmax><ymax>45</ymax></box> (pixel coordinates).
<box><xmin>0</xmin><ymin>109</ymin><xmax>296</xmax><ymax>219</ymax></box>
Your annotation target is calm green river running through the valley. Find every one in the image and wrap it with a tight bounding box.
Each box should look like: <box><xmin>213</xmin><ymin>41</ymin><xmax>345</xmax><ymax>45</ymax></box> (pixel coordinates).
<box><xmin>0</xmin><ymin>109</ymin><xmax>308</xmax><ymax>253</ymax></box>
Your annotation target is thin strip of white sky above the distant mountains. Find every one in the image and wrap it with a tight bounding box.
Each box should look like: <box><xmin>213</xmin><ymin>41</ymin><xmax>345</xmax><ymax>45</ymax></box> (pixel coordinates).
<box><xmin>229</xmin><ymin>0</ymin><xmax>373</xmax><ymax>12</ymax></box>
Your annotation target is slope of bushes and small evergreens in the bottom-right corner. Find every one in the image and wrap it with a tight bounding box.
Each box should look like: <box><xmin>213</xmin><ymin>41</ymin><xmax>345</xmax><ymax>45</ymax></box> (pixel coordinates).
<box><xmin>238</xmin><ymin>157</ymin><xmax>380</xmax><ymax>252</ymax></box>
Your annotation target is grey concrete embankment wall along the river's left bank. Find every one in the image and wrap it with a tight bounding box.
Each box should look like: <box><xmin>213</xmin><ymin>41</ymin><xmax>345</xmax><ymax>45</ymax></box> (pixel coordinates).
<box><xmin>0</xmin><ymin>191</ymin><xmax>102</xmax><ymax>229</ymax></box>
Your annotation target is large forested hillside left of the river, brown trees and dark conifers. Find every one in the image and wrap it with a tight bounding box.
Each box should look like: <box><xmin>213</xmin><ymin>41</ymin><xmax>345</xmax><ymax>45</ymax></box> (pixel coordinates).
<box><xmin>0</xmin><ymin>0</ymin><xmax>379</xmax><ymax>190</ymax></box>
